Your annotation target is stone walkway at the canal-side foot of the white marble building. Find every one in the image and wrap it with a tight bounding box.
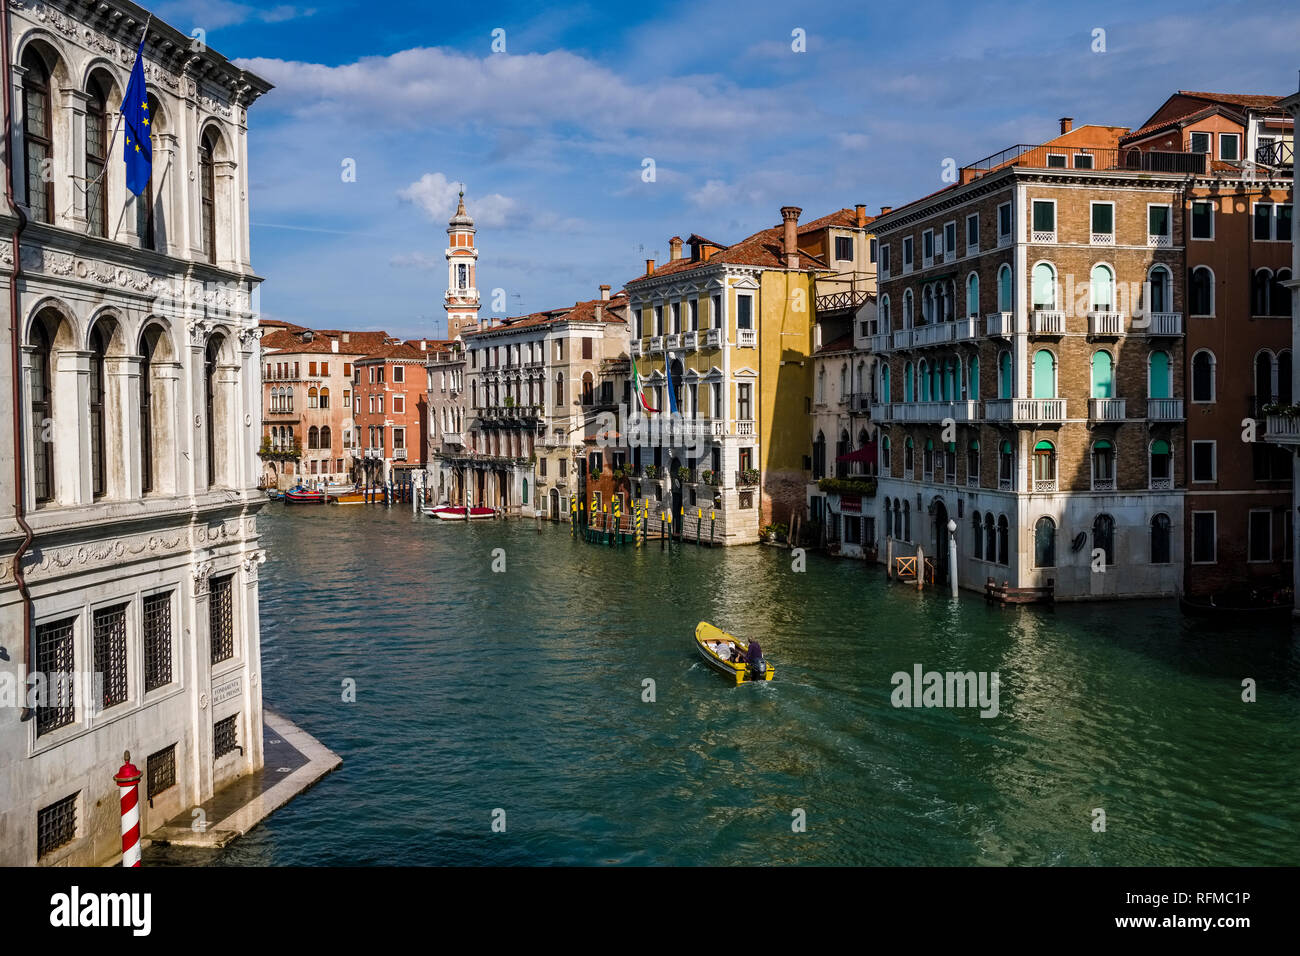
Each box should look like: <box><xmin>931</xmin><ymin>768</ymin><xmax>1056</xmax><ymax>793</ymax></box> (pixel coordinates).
<box><xmin>141</xmin><ymin>710</ymin><xmax>343</xmax><ymax>862</ymax></box>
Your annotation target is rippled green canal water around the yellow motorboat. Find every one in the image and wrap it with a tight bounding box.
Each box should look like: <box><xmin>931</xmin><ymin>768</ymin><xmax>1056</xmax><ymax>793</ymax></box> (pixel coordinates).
<box><xmin>147</xmin><ymin>505</ymin><xmax>1300</xmax><ymax>865</ymax></box>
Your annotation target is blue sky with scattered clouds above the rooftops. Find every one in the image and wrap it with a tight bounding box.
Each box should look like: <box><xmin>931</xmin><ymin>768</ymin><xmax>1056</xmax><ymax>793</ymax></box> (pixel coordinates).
<box><xmin>154</xmin><ymin>0</ymin><xmax>1300</xmax><ymax>338</ymax></box>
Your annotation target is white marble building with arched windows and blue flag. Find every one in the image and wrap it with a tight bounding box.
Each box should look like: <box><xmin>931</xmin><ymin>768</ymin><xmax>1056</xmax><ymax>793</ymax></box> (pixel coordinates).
<box><xmin>0</xmin><ymin>0</ymin><xmax>270</xmax><ymax>865</ymax></box>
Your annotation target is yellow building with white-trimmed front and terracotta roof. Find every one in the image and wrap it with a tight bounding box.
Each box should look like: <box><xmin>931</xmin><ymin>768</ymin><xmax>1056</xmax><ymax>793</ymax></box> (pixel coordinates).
<box><xmin>627</xmin><ymin>206</ymin><xmax>875</xmax><ymax>544</ymax></box>
